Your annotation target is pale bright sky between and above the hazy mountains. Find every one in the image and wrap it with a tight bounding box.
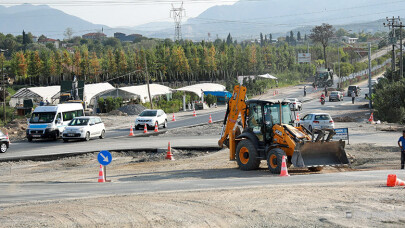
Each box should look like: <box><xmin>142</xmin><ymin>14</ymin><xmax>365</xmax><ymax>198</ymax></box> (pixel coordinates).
<box><xmin>0</xmin><ymin>0</ymin><xmax>237</xmax><ymax>27</ymax></box>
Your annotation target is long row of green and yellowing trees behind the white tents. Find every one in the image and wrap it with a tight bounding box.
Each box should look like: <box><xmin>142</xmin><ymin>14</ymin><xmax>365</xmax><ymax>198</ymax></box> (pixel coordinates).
<box><xmin>0</xmin><ymin>38</ymin><xmax>315</xmax><ymax>85</ymax></box>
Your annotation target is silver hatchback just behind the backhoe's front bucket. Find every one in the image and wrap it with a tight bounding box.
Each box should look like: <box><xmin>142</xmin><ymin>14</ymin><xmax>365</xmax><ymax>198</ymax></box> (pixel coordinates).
<box><xmin>300</xmin><ymin>113</ymin><xmax>335</xmax><ymax>131</ymax></box>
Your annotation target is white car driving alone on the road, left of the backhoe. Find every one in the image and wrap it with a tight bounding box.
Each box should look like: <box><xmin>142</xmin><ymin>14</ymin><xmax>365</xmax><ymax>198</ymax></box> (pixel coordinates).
<box><xmin>135</xmin><ymin>109</ymin><xmax>167</xmax><ymax>130</ymax></box>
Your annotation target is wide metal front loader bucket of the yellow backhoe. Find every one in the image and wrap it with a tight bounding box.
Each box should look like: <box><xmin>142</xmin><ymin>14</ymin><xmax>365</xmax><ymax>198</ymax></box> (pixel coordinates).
<box><xmin>291</xmin><ymin>141</ymin><xmax>349</xmax><ymax>167</ymax></box>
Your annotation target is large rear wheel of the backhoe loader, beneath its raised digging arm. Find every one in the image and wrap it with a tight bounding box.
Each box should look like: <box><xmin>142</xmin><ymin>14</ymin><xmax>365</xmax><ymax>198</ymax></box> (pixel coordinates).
<box><xmin>236</xmin><ymin>139</ymin><xmax>260</xmax><ymax>171</ymax></box>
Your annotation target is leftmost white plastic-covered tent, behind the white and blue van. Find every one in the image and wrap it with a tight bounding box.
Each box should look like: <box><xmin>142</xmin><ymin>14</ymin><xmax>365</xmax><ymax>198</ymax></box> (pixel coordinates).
<box><xmin>9</xmin><ymin>86</ymin><xmax>60</xmax><ymax>107</ymax></box>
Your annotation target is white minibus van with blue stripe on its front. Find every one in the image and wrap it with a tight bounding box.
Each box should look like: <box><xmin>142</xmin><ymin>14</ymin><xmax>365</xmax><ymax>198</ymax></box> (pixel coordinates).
<box><xmin>27</xmin><ymin>103</ymin><xmax>84</xmax><ymax>142</ymax></box>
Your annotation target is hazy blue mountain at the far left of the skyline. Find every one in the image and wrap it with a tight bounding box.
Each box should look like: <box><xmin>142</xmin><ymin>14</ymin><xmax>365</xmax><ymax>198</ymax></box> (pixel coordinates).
<box><xmin>0</xmin><ymin>4</ymin><xmax>111</xmax><ymax>39</ymax></box>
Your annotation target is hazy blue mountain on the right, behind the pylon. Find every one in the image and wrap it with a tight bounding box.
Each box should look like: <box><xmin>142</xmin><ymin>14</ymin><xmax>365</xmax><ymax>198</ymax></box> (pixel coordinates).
<box><xmin>182</xmin><ymin>0</ymin><xmax>405</xmax><ymax>39</ymax></box>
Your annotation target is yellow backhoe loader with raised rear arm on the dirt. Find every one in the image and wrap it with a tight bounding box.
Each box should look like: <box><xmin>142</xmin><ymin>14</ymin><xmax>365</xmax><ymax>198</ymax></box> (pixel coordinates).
<box><xmin>218</xmin><ymin>85</ymin><xmax>349</xmax><ymax>173</ymax></box>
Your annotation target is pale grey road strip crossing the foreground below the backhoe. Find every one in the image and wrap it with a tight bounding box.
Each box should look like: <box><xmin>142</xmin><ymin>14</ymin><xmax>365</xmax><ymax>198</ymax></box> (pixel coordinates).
<box><xmin>0</xmin><ymin>170</ymin><xmax>405</xmax><ymax>204</ymax></box>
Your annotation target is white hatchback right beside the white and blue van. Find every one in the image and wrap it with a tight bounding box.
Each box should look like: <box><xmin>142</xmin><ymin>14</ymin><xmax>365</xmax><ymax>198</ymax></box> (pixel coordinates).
<box><xmin>62</xmin><ymin>116</ymin><xmax>105</xmax><ymax>142</ymax></box>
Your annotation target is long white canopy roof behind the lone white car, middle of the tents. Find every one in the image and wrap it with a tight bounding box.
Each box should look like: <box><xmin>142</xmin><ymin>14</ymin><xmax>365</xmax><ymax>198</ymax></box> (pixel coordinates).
<box><xmin>99</xmin><ymin>84</ymin><xmax>172</xmax><ymax>103</ymax></box>
